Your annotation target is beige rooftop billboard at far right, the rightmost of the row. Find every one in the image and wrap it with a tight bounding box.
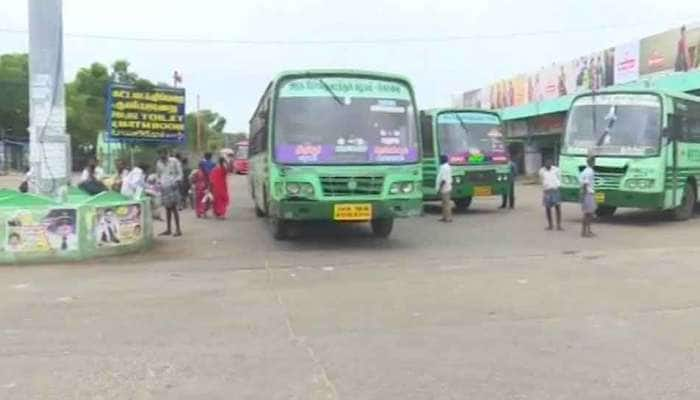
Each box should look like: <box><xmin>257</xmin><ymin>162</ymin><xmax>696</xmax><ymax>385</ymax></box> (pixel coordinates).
<box><xmin>639</xmin><ymin>24</ymin><xmax>700</xmax><ymax>75</ymax></box>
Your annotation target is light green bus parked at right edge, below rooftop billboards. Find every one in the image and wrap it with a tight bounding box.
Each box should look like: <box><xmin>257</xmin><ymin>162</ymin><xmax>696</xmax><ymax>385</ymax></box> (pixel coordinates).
<box><xmin>559</xmin><ymin>90</ymin><xmax>700</xmax><ymax>220</ymax></box>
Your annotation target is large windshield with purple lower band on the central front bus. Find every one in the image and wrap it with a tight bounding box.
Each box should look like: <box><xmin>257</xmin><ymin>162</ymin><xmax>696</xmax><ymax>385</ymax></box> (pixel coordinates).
<box><xmin>274</xmin><ymin>77</ymin><xmax>418</xmax><ymax>164</ymax></box>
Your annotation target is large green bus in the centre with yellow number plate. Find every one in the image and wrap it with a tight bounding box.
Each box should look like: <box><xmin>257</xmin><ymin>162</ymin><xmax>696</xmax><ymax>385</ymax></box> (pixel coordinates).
<box><xmin>249</xmin><ymin>70</ymin><xmax>422</xmax><ymax>239</ymax></box>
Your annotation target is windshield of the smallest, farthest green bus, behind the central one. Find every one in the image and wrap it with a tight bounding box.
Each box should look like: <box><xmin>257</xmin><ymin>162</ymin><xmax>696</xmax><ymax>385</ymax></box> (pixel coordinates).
<box><xmin>437</xmin><ymin>112</ymin><xmax>508</xmax><ymax>164</ymax></box>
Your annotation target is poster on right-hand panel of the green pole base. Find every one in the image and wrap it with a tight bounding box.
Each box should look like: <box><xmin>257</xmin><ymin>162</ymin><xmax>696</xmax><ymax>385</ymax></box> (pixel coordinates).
<box><xmin>95</xmin><ymin>204</ymin><xmax>143</xmax><ymax>247</ymax></box>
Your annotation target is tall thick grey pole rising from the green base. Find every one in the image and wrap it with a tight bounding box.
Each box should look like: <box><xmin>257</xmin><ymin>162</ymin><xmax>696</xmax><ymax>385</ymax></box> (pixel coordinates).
<box><xmin>29</xmin><ymin>0</ymin><xmax>71</xmax><ymax>195</ymax></box>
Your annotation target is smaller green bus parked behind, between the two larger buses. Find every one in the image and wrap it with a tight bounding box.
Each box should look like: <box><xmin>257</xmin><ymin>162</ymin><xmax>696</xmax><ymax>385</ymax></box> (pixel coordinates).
<box><xmin>420</xmin><ymin>109</ymin><xmax>512</xmax><ymax>210</ymax></box>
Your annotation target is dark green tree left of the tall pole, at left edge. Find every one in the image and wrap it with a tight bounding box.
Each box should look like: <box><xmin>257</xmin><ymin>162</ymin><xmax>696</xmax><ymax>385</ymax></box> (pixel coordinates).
<box><xmin>0</xmin><ymin>54</ymin><xmax>29</xmax><ymax>138</ymax></box>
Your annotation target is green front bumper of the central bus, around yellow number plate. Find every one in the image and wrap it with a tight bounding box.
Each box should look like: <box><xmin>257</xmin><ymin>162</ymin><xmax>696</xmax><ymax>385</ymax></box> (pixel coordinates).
<box><xmin>270</xmin><ymin>199</ymin><xmax>423</xmax><ymax>222</ymax></box>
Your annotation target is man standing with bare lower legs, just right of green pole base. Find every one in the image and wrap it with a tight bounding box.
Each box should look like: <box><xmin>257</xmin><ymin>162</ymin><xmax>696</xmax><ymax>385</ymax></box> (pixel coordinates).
<box><xmin>156</xmin><ymin>149</ymin><xmax>183</xmax><ymax>236</ymax></box>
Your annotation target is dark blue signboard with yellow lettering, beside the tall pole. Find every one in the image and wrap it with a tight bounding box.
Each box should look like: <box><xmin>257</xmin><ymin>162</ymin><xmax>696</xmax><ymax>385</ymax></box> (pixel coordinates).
<box><xmin>106</xmin><ymin>84</ymin><xmax>185</xmax><ymax>143</ymax></box>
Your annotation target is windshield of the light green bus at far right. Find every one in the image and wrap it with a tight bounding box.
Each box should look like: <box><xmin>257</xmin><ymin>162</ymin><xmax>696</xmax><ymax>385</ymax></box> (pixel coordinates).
<box><xmin>564</xmin><ymin>94</ymin><xmax>661</xmax><ymax>156</ymax></box>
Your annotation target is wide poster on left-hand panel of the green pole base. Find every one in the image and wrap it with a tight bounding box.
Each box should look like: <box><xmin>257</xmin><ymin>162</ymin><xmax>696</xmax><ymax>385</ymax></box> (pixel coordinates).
<box><xmin>4</xmin><ymin>208</ymin><xmax>78</xmax><ymax>253</ymax></box>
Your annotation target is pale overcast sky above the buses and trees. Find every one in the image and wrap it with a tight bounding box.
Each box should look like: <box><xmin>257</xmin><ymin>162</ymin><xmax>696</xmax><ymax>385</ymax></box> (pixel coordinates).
<box><xmin>0</xmin><ymin>0</ymin><xmax>700</xmax><ymax>131</ymax></box>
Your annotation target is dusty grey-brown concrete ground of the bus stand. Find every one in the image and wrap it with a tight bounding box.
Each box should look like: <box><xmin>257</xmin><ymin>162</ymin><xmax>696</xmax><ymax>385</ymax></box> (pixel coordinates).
<box><xmin>0</xmin><ymin>177</ymin><xmax>700</xmax><ymax>400</ymax></box>
